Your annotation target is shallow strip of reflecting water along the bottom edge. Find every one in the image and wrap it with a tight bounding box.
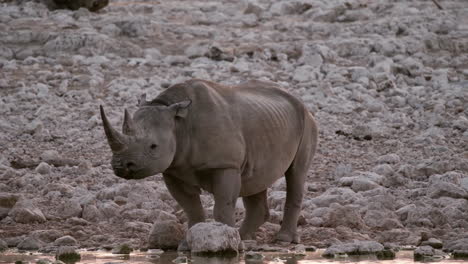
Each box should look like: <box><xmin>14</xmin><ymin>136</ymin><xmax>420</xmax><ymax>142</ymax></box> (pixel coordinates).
<box><xmin>0</xmin><ymin>250</ymin><xmax>468</xmax><ymax>264</ymax></box>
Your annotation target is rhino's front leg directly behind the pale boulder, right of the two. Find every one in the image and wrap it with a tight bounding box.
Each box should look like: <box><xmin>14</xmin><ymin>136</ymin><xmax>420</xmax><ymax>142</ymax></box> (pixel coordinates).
<box><xmin>211</xmin><ymin>169</ymin><xmax>241</xmax><ymax>226</ymax></box>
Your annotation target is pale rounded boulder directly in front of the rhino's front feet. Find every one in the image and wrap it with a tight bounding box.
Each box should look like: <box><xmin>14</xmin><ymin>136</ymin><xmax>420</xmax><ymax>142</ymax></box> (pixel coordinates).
<box><xmin>187</xmin><ymin>222</ymin><xmax>241</xmax><ymax>254</ymax></box>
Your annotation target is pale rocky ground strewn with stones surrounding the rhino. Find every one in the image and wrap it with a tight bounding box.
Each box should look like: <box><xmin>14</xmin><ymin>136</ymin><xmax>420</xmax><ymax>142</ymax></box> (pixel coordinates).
<box><xmin>0</xmin><ymin>0</ymin><xmax>468</xmax><ymax>254</ymax></box>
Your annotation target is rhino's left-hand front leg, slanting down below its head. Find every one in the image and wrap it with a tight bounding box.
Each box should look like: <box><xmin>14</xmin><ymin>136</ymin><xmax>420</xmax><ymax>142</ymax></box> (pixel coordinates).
<box><xmin>163</xmin><ymin>175</ymin><xmax>205</xmax><ymax>227</ymax></box>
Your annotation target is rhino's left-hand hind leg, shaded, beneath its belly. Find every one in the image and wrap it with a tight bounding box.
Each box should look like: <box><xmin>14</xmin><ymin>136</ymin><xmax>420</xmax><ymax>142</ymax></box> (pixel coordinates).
<box><xmin>239</xmin><ymin>190</ymin><xmax>270</xmax><ymax>240</ymax></box>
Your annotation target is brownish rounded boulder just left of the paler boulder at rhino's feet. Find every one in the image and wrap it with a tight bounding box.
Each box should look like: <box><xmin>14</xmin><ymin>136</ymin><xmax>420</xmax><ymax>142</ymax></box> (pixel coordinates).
<box><xmin>148</xmin><ymin>220</ymin><xmax>184</xmax><ymax>249</ymax></box>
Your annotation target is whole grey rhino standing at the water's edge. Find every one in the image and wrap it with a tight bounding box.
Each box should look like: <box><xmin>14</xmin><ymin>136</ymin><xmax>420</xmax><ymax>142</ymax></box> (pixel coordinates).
<box><xmin>101</xmin><ymin>80</ymin><xmax>318</xmax><ymax>243</ymax></box>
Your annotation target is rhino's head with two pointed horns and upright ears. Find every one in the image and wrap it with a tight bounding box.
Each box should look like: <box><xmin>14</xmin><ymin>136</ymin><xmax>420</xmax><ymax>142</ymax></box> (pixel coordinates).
<box><xmin>100</xmin><ymin>95</ymin><xmax>191</xmax><ymax>179</ymax></box>
